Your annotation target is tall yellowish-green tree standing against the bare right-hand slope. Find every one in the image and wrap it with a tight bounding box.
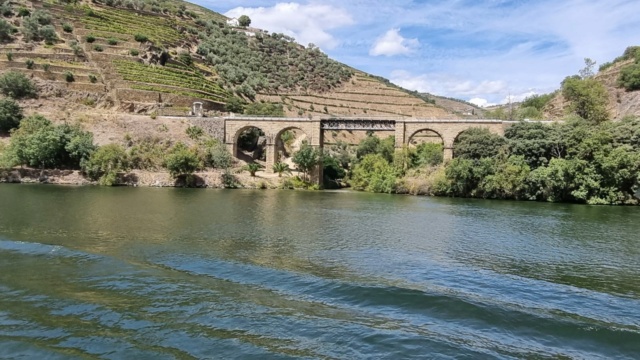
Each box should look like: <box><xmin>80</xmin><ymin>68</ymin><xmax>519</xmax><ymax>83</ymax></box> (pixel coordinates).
<box><xmin>562</xmin><ymin>76</ymin><xmax>609</xmax><ymax>123</ymax></box>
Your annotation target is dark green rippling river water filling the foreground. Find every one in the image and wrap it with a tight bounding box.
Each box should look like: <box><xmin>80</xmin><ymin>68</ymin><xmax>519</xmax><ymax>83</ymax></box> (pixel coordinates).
<box><xmin>0</xmin><ymin>185</ymin><xmax>640</xmax><ymax>360</ymax></box>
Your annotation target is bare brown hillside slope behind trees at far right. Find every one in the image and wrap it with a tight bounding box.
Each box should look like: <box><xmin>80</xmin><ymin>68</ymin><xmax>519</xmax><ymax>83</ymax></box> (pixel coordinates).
<box><xmin>544</xmin><ymin>47</ymin><xmax>640</xmax><ymax>120</ymax></box>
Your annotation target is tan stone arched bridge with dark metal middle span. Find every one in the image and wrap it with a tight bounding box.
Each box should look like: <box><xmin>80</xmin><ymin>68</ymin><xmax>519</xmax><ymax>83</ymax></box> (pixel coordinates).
<box><xmin>224</xmin><ymin>116</ymin><xmax>544</xmax><ymax>180</ymax></box>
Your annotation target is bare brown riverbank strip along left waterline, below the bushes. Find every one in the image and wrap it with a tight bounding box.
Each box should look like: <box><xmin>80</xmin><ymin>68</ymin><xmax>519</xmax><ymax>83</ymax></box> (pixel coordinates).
<box><xmin>0</xmin><ymin>168</ymin><xmax>291</xmax><ymax>189</ymax></box>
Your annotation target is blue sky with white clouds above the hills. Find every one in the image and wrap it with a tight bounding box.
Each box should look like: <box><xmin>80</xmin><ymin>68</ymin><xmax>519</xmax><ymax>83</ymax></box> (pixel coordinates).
<box><xmin>194</xmin><ymin>0</ymin><xmax>640</xmax><ymax>106</ymax></box>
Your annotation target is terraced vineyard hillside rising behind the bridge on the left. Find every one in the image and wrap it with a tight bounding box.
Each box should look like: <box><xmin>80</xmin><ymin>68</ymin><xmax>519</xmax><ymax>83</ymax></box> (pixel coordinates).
<box><xmin>0</xmin><ymin>0</ymin><xmax>457</xmax><ymax>138</ymax></box>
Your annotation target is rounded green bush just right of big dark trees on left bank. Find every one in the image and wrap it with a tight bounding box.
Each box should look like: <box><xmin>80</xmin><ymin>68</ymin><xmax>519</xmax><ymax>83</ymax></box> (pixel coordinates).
<box><xmin>82</xmin><ymin>144</ymin><xmax>129</xmax><ymax>186</ymax></box>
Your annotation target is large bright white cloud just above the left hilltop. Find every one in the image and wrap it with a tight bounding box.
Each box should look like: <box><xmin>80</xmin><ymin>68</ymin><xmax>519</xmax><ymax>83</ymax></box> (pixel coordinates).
<box><xmin>225</xmin><ymin>2</ymin><xmax>353</xmax><ymax>49</ymax></box>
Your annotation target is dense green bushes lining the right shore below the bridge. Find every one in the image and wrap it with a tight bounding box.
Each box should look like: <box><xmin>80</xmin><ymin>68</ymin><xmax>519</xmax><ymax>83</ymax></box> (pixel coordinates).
<box><xmin>336</xmin><ymin>117</ymin><xmax>640</xmax><ymax>205</ymax></box>
